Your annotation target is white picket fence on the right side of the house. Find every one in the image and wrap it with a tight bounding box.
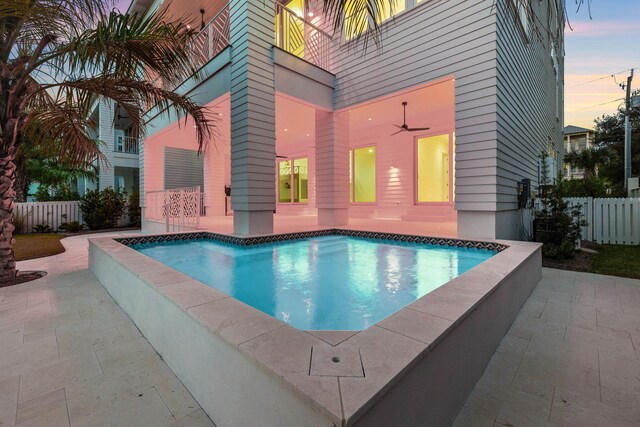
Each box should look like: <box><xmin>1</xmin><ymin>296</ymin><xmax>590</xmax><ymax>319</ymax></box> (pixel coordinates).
<box><xmin>567</xmin><ymin>197</ymin><xmax>640</xmax><ymax>245</ymax></box>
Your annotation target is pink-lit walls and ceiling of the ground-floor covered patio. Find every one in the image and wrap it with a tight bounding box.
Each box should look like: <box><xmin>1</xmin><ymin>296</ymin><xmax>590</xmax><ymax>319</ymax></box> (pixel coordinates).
<box><xmin>144</xmin><ymin>80</ymin><xmax>456</xmax><ymax>221</ymax></box>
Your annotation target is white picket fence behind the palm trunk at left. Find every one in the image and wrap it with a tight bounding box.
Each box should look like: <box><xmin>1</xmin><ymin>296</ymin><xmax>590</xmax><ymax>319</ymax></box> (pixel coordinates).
<box><xmin>14</xmin><ymin>201</ymin><xmax>84</xmax><ymax>233</ymax></box>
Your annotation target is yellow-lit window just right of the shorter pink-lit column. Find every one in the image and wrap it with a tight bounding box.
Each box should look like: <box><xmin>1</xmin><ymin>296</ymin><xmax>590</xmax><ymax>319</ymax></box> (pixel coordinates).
<box><xmin>349</xmin><ymin>146</ymin><xmax>376</xmax><ymax>203</ymax></box>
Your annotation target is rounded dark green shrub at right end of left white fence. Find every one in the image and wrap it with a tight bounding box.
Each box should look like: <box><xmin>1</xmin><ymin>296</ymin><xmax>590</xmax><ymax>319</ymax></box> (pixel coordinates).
<box><xmin>80</xmin><ymin>187</ymin><xmax>126</xmax><ymax>230</ymax></box>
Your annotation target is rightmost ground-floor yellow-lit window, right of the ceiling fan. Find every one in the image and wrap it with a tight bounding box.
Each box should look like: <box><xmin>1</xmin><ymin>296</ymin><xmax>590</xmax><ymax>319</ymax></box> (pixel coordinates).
<box><xmin>417</xmin><ymin>135</ymin><xmax>450</xmax><ymax>203</ymax></box>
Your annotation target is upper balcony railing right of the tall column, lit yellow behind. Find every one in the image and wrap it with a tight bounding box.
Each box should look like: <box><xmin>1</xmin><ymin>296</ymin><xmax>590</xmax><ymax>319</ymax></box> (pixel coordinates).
<box><xmin>275</xmin><ymin>1</ymin><xmax>332</xmax><ymax>71</ymax></box>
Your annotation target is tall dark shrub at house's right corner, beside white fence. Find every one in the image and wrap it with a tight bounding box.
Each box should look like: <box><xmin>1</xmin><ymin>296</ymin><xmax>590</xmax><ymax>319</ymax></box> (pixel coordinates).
<box><xmin>535</xmin><ymin>155</ymin><xmax>587</xmax><ymax>259</ymax></box>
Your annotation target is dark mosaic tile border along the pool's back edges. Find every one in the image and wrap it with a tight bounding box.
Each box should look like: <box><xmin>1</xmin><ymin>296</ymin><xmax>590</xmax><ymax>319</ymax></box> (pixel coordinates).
<box><xmin>115</xmin><ymin>228</ymin><xmax>509</xmax><ymax>252</ymax></box>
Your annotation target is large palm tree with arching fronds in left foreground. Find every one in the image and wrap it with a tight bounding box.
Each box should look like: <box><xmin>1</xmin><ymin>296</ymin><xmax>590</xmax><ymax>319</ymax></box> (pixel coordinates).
<box><xmin>0</xmin><ymin>0</ymin><xmax>213</xmax><ymax>286</ymax></box>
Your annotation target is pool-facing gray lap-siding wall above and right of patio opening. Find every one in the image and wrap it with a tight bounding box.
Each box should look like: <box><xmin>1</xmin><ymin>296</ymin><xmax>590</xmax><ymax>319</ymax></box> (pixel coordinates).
<box><xmin>335</xmin><ymin>0</ymin><xmax>497</xmax><ymax>211</ymax></box>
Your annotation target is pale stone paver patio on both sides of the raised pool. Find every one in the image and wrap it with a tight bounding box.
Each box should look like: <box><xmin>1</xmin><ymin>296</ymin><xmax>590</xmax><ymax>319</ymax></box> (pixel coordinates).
<box><xmin>0</xmin><ymin>235</ymin><xmax>640</xmax><ymax>426</ymax></box>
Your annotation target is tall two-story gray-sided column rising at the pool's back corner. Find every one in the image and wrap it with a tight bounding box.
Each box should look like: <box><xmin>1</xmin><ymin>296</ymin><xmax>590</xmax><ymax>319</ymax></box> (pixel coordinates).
<box><xmin>230</xmin><ymin>0</ymin><xmax>276</xmax><ymax>235</ymax></box>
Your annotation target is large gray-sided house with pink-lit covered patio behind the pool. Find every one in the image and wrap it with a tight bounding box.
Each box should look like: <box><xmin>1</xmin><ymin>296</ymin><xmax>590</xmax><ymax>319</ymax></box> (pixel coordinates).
<box><xmin>130</xmin><ymin>0</ymin><xmax>564</xmax><ymax>239</ymax></box>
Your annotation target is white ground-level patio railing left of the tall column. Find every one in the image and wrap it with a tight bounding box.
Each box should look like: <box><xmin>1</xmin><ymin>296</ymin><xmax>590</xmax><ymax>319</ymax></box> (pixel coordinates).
<box><xmin>145</xmin><ymin>186</ymin><xmax>203</xmax><ymax>232</ymax></box>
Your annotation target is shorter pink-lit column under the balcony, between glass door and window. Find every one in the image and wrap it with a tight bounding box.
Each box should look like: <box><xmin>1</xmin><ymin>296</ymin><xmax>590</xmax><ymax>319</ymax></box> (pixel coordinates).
<box><xmin>315</xmin><ymin>110</ymin><xmax>349</xmax><ymax>226</ymax></box>
